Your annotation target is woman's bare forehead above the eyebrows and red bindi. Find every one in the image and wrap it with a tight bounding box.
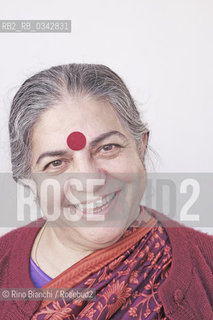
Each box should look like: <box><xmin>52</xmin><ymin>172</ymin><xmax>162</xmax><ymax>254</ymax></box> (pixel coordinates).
<box><xmin>32</xmin><ymin>98</ymin><xmax>128</xmax><ymax>149</ymax></box>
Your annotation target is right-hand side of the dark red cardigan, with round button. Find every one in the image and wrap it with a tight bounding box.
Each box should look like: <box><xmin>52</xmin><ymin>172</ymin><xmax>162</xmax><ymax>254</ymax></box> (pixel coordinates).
<box><xmin>148</xmin><ymin>209</ymin><xmax>213</xmax><ymax>319</ymax></box>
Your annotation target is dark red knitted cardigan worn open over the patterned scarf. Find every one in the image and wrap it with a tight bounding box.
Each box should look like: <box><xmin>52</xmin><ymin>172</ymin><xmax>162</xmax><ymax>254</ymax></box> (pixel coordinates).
<box><xmin>0</xmin><ymin>209</ymin><xmax>213</xmax><ymax>320</ymax></box>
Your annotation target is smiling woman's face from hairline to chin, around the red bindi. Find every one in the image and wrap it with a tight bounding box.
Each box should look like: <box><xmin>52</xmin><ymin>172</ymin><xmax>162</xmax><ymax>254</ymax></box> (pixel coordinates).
<box><xmin>31</xmin><ymin>97</ymin><xmax>146</xmax><ymax>249</ymax></box>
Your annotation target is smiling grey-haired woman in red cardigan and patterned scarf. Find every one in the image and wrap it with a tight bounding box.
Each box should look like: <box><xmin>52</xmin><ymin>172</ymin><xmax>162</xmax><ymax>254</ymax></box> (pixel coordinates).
<box><xmin>0</xmin><ymin>64</ymin><xmax>213</xmax><ymax>320</ymax></box>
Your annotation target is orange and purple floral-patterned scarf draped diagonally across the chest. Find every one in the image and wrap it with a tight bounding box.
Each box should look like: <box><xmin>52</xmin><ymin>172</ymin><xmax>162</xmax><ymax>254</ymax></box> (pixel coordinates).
<box><xmin>32</xmin><ymin>207</ymin><xmax>172</xmax><ymax>320</ymax></box>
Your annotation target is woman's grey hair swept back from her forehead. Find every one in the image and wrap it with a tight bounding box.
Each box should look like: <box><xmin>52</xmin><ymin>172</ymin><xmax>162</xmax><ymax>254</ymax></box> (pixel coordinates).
<box><xmin>9</xmin><ymin>63</ymin><xmax>149</xmax><ymax>181</ymax></box>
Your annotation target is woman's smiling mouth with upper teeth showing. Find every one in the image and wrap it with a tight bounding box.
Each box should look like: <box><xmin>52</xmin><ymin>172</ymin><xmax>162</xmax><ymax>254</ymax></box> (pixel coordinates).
<box><xmin>73</xmin><ymin>192</ymin><xmax>118</xmax><ymax>214</ymax></box>
